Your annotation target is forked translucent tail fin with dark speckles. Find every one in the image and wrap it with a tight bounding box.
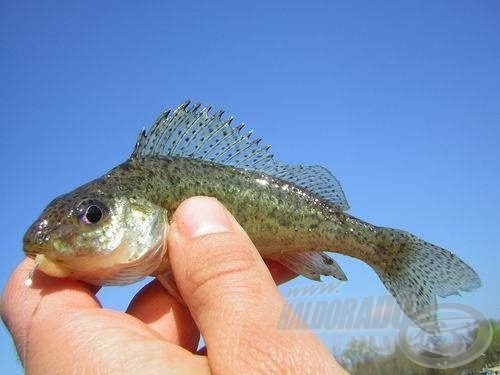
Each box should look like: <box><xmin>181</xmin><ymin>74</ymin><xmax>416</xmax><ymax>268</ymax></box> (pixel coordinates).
<box><xmin>370</xmin><ymin>228</ymin><xmax>481</xmax><ymax>333</ymax></box>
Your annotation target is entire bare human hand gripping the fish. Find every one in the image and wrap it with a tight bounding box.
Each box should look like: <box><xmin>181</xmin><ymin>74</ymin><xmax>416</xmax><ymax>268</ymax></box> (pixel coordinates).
<box><xmin>1</xmin><ymin>197</ymin><xmax>345</xmax><ymax>374</ymax></box>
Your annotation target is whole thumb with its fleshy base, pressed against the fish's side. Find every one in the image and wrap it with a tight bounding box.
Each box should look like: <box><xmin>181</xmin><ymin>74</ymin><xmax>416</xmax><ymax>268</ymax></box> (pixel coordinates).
<box><xmin>168</xmin><ymin>197</ymin><xmax>340</xmax><ymax>373</ymax></box>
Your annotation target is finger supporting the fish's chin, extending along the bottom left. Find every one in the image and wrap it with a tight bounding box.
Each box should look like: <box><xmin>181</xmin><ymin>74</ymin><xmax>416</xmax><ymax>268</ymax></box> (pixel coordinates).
<box><xmin>1</xmin><ymin>260</ymin><xmax>206</xmax><ymax>374</ymax></box>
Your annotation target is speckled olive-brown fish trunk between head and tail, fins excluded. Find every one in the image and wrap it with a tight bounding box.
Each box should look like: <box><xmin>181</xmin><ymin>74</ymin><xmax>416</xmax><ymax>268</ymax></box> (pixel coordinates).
<box><xmin>125</xmin><ymin>157</ymin><xmax>374</xmax><ymax>258</ymax></box>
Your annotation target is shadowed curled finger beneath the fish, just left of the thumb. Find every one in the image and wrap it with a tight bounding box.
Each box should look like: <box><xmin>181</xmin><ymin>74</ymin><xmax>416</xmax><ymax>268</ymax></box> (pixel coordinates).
<box><xmin>127</xmin><ymin>280</ymin><xmax>200</xmax><ymax>352</ymax></box>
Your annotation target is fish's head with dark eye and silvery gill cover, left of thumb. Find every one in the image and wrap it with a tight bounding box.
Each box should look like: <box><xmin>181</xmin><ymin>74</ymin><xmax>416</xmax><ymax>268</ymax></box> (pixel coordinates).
<box><xmin>23</xmin><ymin>181</ymin><xmax>168</xmax><ymax>285</ymax></box>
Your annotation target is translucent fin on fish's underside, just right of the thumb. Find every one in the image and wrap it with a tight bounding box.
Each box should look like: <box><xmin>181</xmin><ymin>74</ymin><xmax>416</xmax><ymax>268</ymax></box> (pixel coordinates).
<box><xmin>272</xmin><ymin>252</ymin><xmax>347</xmax><ymax>281</ymax></box>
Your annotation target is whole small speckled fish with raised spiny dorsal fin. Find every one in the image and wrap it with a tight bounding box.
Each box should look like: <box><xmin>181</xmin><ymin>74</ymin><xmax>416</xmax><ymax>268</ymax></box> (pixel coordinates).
<box><xmin>23</xmin><ymin>101</ymin><xmax>481</xmax><ymax>332</ymax></box>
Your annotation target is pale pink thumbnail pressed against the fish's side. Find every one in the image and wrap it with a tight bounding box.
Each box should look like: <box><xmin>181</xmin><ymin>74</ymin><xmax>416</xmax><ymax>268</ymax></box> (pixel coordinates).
<box><xmin>175</xmin><ymin>197</ymin><xmax>234</xmax><ymax>238</ymax></box>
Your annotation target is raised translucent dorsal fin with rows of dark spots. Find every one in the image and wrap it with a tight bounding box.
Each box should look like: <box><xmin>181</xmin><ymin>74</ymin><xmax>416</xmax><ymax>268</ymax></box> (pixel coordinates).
<box><xmin>131</xmin><ymin>101</ymin><xmax>349</xmax><ymax>210</ymax></box>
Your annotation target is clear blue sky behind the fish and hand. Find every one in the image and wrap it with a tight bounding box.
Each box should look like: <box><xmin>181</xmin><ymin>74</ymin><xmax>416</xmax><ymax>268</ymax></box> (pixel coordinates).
<box><xmin>0</xmin><ymin>1</ymin><xmax>500</xmax><ymax>373</ymax></box>
